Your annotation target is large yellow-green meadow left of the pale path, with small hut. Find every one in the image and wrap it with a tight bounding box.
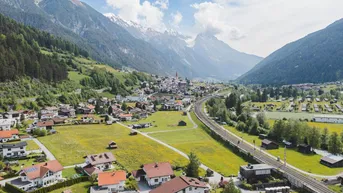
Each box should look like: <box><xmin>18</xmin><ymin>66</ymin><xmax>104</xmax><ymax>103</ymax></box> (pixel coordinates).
<box><xmin>39</xmin><ymin>124</ymin><xmax>187</xmax><ymax>171</ymax></box>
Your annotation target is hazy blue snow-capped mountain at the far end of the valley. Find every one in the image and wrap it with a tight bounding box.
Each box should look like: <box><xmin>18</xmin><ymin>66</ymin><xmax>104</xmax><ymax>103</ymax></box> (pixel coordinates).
<box><xmin>105</xmin><ymin>13</ymin><xmax>262</xmax><ymax>80</ymax></box>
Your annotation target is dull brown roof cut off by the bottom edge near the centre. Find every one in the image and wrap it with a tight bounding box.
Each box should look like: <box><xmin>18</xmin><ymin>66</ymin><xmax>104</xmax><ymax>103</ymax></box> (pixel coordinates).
<box><xmin>149</xmin><ymin>176</ymin><xmax>207</xmax><ymax>193</ymax></box>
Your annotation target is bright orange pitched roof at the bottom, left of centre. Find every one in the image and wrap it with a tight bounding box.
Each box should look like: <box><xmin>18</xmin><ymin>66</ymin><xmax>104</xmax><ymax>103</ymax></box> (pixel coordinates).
<box><xmin>98</xmin><ymin>171</ymin><xmax>126</xmax><ymax>186</ymax></box>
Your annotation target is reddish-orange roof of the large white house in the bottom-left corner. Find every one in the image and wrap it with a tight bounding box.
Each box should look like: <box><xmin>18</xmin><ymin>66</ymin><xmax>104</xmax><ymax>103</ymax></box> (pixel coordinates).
<box><xmin>22</xmin><ymin>160</ymin><xmax>63</xmax><ymax>180</ymax></box>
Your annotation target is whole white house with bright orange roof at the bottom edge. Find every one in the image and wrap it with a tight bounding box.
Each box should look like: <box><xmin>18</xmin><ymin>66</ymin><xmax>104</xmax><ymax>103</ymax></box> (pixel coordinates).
<box><xmin>90</xmin><ymin>171</ymin><xmax>126</xmax><ymax>193</ymax></box>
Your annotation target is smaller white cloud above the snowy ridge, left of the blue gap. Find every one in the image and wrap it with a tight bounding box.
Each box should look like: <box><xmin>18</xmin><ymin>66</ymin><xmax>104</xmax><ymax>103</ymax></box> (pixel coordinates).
<box><xmin>106</xmin><ymin>0</ymin><xmax>168</xmax><ymax>31</ymax></box>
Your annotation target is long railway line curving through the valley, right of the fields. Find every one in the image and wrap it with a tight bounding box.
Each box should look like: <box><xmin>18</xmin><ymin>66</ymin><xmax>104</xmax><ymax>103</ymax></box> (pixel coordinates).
<box><xmin>195</xmin><ymin>97</ymin><xmax>334</xmax><ymax>193</ymax></box>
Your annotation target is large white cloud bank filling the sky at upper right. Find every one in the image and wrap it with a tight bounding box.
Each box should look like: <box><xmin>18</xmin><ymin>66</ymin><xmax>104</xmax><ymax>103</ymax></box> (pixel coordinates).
<box><xmin>191</xmin><ymin>0</ymin><xmax>343</xmax><ymax>56</ymax></box>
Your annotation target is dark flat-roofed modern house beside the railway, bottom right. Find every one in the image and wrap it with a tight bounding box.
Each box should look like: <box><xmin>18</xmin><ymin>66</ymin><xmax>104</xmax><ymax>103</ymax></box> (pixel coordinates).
<box><xmin>238</xmin><ymin>164</ymin><xmax>274</xmax><ymax>183</ymax></box>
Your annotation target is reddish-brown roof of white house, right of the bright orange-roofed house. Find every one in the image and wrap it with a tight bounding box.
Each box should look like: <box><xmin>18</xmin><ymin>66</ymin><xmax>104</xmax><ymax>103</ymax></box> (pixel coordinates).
<box><xmin>143</xmin><ymin>162</ymin><xmax>174</xmax><ymax>178</ymax></box>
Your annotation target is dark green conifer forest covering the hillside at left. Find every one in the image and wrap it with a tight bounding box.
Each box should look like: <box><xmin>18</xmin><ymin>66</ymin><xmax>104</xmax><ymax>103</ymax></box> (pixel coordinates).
<box><xmin>0</xmin><ymin>14</ymin><xmax>88</xmax><ymax>82</ymax></box>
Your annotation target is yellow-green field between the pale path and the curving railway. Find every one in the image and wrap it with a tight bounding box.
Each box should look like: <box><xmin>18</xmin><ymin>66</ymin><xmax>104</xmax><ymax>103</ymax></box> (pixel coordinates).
<box><xmin>150</xmin><ymin>113</ymin><xmax>247</xmax><ymax>176</ymax></box>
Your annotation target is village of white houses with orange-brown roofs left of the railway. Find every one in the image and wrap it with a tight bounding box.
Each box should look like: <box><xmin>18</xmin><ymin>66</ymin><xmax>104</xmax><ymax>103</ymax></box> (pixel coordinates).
<box><xmin>0</xmin><ymin>75</ymin><xmax>236</xmax><ymax>193</ymax></box>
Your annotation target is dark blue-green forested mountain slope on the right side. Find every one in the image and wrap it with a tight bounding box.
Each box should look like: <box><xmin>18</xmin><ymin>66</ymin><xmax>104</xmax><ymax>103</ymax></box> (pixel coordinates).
<box><xmin>237</xmin><ymin>19</ymin><xmax>343</xmax><ymax>84</ymax></box>
